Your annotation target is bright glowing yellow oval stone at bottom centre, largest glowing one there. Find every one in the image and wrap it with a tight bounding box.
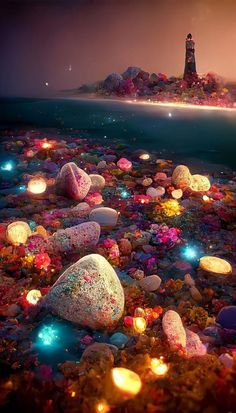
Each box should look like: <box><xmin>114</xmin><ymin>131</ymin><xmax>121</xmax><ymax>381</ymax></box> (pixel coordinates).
<box><xmin>112</xmin><ymin>367</ymin><xmax>142</xmax><ymax>397</ymax></box>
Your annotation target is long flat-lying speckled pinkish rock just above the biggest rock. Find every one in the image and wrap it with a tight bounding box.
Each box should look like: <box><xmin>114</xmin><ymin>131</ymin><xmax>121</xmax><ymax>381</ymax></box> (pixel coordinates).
<box><xmin>48</xmin><ymin>222</ymin><xmax>101</xmax><ymax>253</ymax></box>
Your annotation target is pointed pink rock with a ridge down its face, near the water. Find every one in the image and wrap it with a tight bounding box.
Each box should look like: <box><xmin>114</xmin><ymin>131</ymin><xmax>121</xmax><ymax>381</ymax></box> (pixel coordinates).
<box><xmin>57</xmin><ymin>162</ymin><xmax>91</xmax><ymax>201</ymax></box>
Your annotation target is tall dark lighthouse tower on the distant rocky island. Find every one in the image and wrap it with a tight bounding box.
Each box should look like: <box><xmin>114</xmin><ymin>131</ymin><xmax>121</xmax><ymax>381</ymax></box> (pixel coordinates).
<box><xmin>184</xmin><ymin>33</ymin><xmax>198</xmax><ymax>86</ymax></box>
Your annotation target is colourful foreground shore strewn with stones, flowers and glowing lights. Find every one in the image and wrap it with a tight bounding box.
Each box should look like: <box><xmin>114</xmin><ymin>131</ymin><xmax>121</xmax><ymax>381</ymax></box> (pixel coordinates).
<box><xmin>0</xmin><ymin>130</ymin><xmax>236</xmax><ymax>413</ymax></box>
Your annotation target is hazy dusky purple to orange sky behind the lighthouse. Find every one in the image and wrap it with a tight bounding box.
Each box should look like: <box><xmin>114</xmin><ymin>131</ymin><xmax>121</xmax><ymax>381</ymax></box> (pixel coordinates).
<box><xmin>0</xmin><ymin>0</ymin><xmax>236</xmax><ymax>95</ymax></box>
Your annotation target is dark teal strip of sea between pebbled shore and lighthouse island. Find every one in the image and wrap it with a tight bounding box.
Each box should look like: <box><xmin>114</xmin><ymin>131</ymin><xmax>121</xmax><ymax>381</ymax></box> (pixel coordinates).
<box><xmin>0</xmin><ymin>98</ymin><xmax>236</xmax><ymax>171</ymax></box>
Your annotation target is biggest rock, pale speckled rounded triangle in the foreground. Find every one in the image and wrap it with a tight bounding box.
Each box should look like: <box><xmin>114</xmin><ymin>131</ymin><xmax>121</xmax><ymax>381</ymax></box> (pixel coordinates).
<box><xmin>45</xmin><ymin>254</ymin><xmax>124</xmax><ymax>329</ymax></box>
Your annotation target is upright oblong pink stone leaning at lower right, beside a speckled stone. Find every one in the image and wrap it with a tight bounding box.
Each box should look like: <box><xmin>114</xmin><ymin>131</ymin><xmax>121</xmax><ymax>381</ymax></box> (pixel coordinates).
<box><xmin>162</xmin><ymin>310</ymin><xmax>186</xmax><ymax>350</ymax></box>
